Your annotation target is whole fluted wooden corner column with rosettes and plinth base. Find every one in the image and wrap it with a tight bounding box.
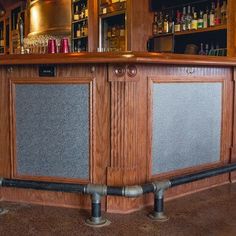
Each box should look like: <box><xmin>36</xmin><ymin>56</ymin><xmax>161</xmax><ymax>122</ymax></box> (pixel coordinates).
<box><xmin>107</xmin><ymin>65</ymin><xmax>146</xmax><ymax>212</ymax></box>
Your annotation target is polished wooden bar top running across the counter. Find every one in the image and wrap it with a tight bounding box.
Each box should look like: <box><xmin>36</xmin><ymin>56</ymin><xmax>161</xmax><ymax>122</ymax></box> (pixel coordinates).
<box><xmin>0</xmin><ymin>52</ymin><xmax>236</xmax><ymax>66</ymax></box>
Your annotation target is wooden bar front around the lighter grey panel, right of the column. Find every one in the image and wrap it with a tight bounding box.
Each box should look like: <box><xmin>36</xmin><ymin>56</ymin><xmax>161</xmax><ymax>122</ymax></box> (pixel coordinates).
<box><xmin>146</xmin><ymin>66</ymin><xmax>233</xmax><ymax>206</ymax></box>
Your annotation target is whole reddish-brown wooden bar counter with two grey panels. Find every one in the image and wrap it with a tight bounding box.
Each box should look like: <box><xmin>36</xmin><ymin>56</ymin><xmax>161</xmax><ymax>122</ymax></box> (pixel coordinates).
<box><xmin>0</xmin><ymin>52</ymin><xmax>236</xmax><ymax>213</ymax></box>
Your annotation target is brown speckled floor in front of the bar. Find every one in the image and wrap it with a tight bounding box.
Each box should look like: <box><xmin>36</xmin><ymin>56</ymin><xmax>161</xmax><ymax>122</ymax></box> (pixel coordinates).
<box><xmin>0</xmin><ymin>184</ymin><xmax>236</xmax><ymax>236</ymax></box>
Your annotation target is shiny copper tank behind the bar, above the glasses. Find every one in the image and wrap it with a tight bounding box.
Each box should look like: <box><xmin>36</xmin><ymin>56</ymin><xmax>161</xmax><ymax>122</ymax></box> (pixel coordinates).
<box><xmin>27</xmin><ymin>0</ymin><xmax>71</xmax><ymax>37</ymax></box>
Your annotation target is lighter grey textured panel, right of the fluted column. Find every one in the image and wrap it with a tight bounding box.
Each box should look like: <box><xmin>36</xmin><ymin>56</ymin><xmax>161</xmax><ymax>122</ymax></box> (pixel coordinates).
<box><xmin>152</xmin><ymin>83</ymin><xmax>222</xmax><ymax>174</ymax></box>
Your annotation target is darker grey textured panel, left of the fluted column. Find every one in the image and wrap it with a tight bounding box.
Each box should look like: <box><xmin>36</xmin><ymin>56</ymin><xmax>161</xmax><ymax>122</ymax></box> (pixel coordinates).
<box><xmin>16</xmin><ymin>84</ymin><xmax>89</xmax><ymax>179</ymax></box>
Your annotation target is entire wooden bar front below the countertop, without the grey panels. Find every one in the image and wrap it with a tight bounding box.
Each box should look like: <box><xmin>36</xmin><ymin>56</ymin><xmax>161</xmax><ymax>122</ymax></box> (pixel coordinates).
<box><xmin>0</xmin><ymin>63</ymin><xmax>234</xmax><ymax>212</ymax></box>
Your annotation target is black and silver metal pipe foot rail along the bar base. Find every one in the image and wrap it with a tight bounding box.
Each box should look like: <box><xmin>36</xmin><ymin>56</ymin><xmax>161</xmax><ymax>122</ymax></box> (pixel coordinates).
<box><xmin>0</xmin><ymin>163</ymin><xmax>236</xmax><ymax>227</ymax></box>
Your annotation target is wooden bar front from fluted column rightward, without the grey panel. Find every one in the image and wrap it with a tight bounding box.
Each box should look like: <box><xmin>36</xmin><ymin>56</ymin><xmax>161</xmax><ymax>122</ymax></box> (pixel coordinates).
<box><xmin>107</xmin><ymin>65</ymin><xmax>233</xmax><ymax>212</ymax></box>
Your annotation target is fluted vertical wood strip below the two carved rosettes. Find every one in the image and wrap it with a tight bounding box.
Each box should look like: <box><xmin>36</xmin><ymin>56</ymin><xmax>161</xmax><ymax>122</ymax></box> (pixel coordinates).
<box><xmin>111</xmin><ymin>82</ymin><xmax>138</xmax><ymax>168</ymax></box>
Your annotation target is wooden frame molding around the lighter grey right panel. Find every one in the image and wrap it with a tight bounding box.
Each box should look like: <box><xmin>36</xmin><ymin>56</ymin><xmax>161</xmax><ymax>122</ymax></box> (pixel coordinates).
<box><xmin>147</xmin><ymin>73</ymin><xmax>232</xmax><ymax>180</ymax></box>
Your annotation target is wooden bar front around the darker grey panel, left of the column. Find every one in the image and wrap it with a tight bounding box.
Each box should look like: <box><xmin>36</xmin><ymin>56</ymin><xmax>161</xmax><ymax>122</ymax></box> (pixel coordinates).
<box><xmin>0</xmin><ymin>65</ymin><xmax>110</xmax><ymax>208</ymax></box>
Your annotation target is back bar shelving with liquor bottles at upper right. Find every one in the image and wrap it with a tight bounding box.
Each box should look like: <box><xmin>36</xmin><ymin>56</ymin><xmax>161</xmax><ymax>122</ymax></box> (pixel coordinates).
<box><xmin>149</xmin><ymin>0</ymin><xmax>236</xmax><ymax>56</ymax></box>
